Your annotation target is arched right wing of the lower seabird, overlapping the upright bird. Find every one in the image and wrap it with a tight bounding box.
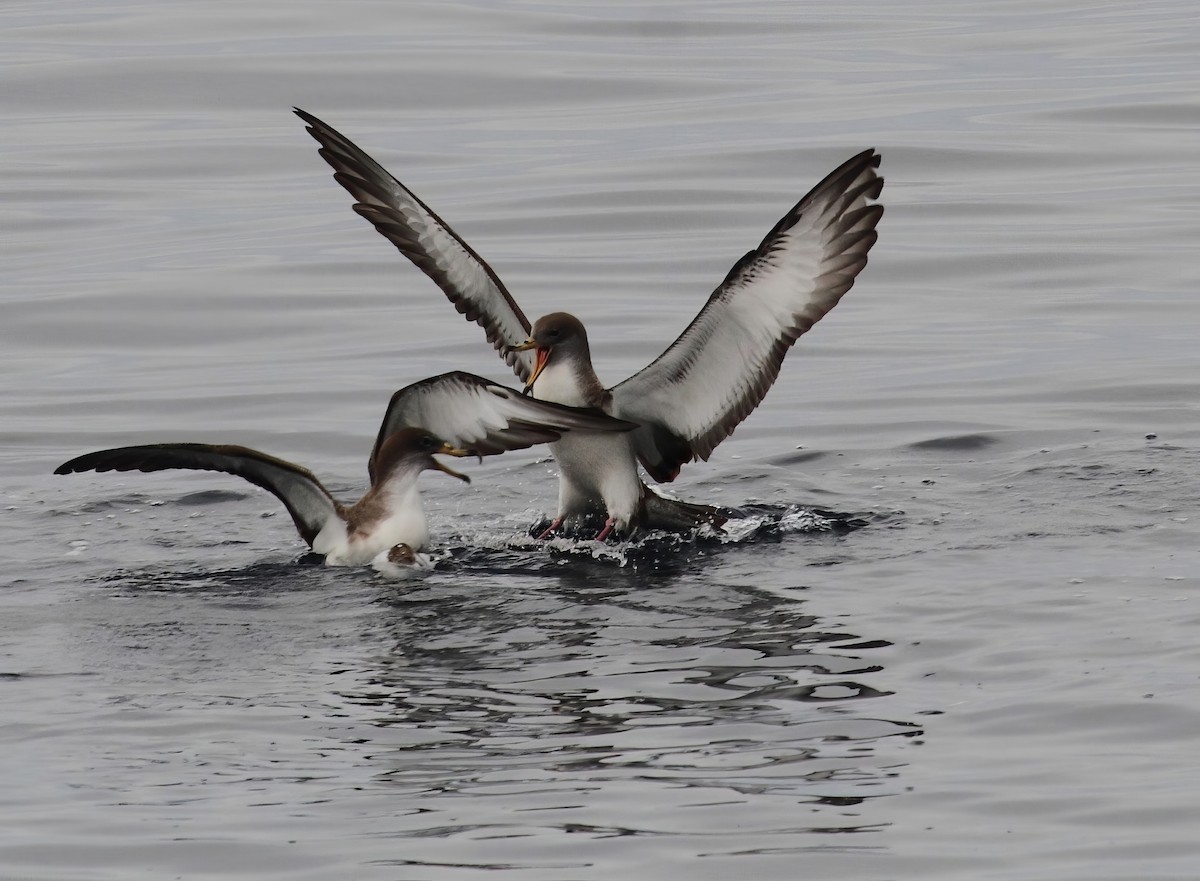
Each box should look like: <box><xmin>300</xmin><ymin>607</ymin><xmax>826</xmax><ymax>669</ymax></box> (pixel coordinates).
<box><xmin>368</xmin><ymin>372</ymin><xmax>637</xmax><ymax>484</ymax></box>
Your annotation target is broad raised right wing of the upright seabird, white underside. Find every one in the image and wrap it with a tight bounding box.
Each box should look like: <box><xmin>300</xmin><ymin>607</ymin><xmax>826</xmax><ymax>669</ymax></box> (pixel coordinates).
<box><xmin>612</xmin><ymin>150</ymin><xmax>883</xmax><ymax>481</ymax></box>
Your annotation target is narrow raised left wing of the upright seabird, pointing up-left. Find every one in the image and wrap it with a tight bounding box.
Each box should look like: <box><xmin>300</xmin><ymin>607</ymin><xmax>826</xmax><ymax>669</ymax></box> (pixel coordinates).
<box><xmin>295</xmin><ymin>108</ymin><xmax>534</xmax><ymax>382</ymax></box>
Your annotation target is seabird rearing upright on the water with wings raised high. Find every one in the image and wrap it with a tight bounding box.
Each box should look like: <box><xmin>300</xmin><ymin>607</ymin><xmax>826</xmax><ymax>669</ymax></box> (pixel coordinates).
<box><xmin>295</xmin><ymin>108</ymin><xmax>883</xmax><ymax>540</ymax></box>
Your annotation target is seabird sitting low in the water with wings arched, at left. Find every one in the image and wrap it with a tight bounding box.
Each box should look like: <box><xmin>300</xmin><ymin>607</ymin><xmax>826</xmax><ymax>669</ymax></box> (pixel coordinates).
<box><xmin>54</xmin><ymin>372</ymin><xmax>635</xmax><ymax>568</ymax></box>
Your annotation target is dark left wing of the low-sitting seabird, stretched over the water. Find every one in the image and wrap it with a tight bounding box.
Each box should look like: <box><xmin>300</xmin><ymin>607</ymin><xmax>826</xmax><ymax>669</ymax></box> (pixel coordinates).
<box><xmin>54</xmin><ymin>444</ymin><xmax>340</xmax><ymax>547</ymax></box>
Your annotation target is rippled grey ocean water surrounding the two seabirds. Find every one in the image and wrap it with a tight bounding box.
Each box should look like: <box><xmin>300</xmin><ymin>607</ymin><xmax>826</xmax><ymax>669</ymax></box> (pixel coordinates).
<box><xmin>0</xmin><ymin>0</ymin><xmax>1200</xmax><ymax>881</ymax></box>
